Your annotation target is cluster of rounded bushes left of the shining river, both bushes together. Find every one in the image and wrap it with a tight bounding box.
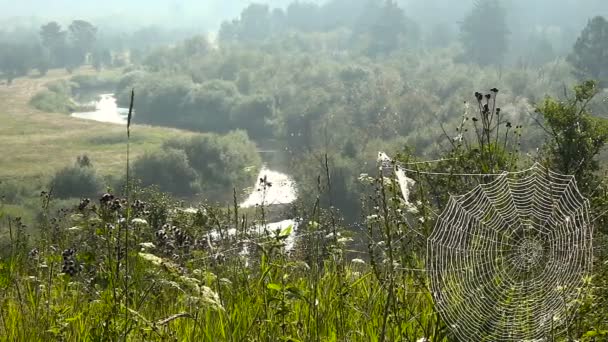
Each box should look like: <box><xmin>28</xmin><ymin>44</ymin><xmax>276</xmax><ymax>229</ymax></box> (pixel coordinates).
<box><xmin>133</xmin><ymin>131</ymin><xmax>261</xmax><ymax>199</ymax></box>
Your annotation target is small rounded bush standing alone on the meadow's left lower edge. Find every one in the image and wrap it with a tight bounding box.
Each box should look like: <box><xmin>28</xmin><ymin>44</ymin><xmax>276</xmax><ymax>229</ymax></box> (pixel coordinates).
<box><xmin>49</xmin><ymin>158</ymin><xmax>102</xmax><ymax>199</ymax></box>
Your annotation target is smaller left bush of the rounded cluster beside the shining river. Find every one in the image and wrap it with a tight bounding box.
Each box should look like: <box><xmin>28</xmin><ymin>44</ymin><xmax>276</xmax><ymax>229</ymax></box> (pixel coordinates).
<box><xmin>133</xmin><ymin>148</ymin><xmax>199</xmax><ymax>196</ymax></box>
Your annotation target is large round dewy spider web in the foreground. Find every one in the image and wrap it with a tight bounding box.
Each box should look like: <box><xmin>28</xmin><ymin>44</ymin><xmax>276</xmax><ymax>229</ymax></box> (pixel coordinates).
<box><xmin>427</xmin><ymin>164</ymin><xmax>593</xmax><ymax>341</ymax></box>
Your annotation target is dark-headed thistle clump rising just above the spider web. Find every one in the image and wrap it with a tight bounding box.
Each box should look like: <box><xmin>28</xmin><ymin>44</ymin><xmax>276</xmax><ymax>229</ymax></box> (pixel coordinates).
<box><xmin>400</xmin><ymin>88</ymin><xmax>529</xmax><ymax>211</ymax></box>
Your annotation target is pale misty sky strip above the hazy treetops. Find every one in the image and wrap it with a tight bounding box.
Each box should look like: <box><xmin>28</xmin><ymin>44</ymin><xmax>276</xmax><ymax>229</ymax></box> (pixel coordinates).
<box><xmin>0</xmin><ymin>0</ymin><xmax>608</xmax><ymax>31</ymax></box>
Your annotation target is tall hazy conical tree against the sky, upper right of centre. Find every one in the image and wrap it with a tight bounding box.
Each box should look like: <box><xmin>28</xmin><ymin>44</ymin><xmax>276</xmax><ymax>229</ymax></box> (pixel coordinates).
<box><xmin>460</xmin><ymin>0</ymin><xmax>509</xmax><ymax>66</ymax></box>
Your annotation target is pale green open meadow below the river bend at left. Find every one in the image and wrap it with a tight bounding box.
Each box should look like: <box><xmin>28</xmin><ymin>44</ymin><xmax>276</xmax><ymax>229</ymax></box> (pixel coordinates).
<box><xmin>0</xmin><ymin>68</ymin><xmax>195</xmax><ymax>180</ymax></box>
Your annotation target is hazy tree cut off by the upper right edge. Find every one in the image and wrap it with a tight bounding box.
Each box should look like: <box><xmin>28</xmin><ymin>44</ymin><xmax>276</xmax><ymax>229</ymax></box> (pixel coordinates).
<box><xmin>568</xmin><ymin>17</ymin><xmax>608</xmax><ymax>86</ymax></box>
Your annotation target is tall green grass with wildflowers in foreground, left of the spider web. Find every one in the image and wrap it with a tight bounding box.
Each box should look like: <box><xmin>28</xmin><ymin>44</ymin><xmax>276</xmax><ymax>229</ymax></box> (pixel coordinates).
<box><xmin>0</xmin><ymin>159</ymin><xmax>443</xmax><ymax>341</ymax></box>
